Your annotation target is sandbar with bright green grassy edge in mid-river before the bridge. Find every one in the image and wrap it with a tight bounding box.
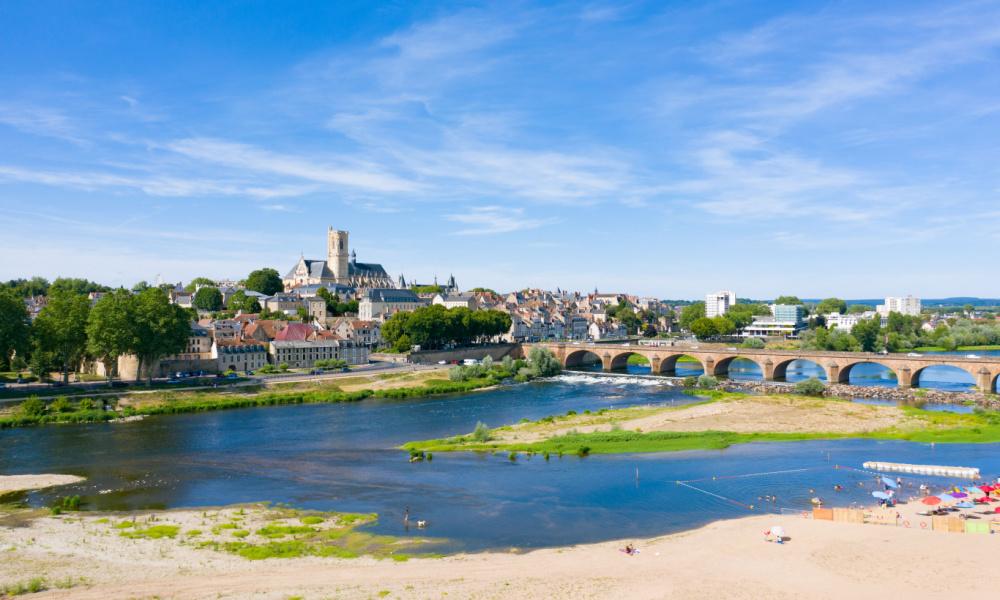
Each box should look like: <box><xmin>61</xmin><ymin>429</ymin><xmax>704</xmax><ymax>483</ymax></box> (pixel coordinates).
<box><xmin>403</xmin><ymin>391</ymin><xmax>1000</xmax><ymax>455</ymax></box>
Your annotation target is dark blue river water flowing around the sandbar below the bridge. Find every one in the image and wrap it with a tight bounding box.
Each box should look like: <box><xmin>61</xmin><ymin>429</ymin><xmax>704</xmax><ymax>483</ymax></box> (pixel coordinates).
<box><xmin>0</xmin><ymin>374</ymin><xmax>1000</xmax><ymax>551</ymax></box>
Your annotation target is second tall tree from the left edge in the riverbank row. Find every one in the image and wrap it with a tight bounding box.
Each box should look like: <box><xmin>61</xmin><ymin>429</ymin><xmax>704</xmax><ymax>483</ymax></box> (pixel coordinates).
<box><xmin>33</xmin><ymin>288</ymin><xmax>90</xmax><ymax>383</ymax></box>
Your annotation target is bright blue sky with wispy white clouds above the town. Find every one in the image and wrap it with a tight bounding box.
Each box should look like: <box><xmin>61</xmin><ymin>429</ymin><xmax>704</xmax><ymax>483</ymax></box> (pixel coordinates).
<box><xmin>0</xmin><ymin>1</ymin><xmax>1000</xmax><ymax>298</ymax></box>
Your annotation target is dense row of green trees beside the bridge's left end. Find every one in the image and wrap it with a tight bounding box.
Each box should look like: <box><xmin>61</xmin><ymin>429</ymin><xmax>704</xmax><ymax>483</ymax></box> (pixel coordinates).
<box><xmin>382</xmin><ymin>304</ymin><xmax>511</xmax><ymax>352</ymax></box>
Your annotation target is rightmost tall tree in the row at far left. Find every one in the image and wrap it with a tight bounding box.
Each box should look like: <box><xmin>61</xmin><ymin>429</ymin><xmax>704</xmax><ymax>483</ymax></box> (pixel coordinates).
<box><xmin>130</xmin><ymin>288</ymin><xmax>191</xmax><ymax>384</ymax></box>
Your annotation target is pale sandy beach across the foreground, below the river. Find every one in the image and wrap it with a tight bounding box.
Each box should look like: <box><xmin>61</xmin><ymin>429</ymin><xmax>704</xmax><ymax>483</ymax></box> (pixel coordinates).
<box><xmin>0</xmin><ymin>504</ymin><xmax>1000</xmax><ymax>600</ymax></box>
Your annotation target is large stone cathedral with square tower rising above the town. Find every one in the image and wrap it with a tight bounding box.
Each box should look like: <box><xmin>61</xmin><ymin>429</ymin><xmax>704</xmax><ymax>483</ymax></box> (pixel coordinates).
<box><xmin>282</xmin><ymin>227</ymin><xmax>394</xmax><ymax>290</ymax></box>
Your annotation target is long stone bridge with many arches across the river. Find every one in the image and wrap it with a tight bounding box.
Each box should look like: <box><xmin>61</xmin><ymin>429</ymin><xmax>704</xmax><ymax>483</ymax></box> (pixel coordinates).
<box><xmin>522</xmin><ymin>342</ymin><xmax>1000</xmax><ymax>392</ymax></box>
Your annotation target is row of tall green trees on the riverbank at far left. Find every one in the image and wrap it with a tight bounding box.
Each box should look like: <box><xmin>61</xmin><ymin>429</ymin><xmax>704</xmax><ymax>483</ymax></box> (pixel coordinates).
<box><xmin>0</xmin><ymin>288</ymin><xmax>191</xmax><ymax>382</ymax></box>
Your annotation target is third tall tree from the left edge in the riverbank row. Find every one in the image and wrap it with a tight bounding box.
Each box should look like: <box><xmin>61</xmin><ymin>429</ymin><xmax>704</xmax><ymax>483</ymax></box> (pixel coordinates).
<box><xmin>87</xmin><ymin>289</ymin><xmax>135</xmax><ymax>383</ymax></box>
